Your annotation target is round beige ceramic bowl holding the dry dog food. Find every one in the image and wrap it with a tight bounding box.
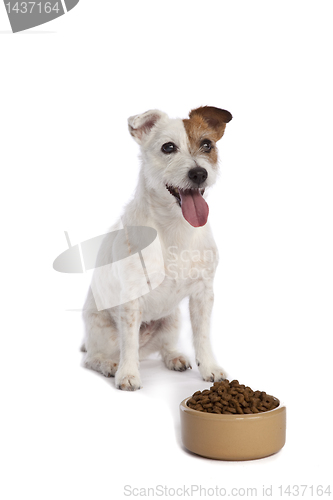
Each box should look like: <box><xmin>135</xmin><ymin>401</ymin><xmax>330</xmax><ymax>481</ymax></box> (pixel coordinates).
<box><xmin>180</xmin><ymin>398</ymin><xmax>286</xmax><ymax>460</ymax></box>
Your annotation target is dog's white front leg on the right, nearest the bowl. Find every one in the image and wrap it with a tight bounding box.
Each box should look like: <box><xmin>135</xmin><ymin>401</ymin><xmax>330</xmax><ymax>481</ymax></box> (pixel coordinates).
<box><xmin>189</xmin><ymin>284</ymin><xmax>225</xmax><ymax>382</ymax></box>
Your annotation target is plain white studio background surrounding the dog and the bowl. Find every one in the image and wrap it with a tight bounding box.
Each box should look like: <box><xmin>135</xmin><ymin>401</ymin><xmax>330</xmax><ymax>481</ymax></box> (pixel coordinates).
<box><xmin>0</xmin><ymin>0</ymin><xmax>333</xmax><ymax>500</ymax></box>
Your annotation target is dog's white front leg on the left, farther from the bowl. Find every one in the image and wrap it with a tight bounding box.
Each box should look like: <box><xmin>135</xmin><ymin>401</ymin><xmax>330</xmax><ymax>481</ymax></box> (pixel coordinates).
<box><xmin>115</xmin><ymin>300</ymin><xmax>142</xmax><ymax>391</ymax></box>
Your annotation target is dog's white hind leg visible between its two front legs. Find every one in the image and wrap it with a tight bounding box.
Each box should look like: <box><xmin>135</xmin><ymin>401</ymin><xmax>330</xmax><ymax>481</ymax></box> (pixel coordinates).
<box><xmin>158</xmin><ymin>308</ymin><xmax>192</xmax><ymax>371</ymax></box>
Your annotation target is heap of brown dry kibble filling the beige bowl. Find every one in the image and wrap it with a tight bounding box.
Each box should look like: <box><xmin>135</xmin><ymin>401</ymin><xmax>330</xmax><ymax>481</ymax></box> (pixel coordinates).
<box><xmin>187</xmin><ymin>380</ymin><xmax>280</xmax><ymax>415</ymax></box>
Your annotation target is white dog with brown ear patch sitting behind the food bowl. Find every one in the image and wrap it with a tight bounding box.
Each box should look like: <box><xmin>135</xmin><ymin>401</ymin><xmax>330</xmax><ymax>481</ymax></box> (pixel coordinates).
<box><xmin>82</xmin><ymin>106</ymin><xmax>232</xmax><ymax>390</ymax></box>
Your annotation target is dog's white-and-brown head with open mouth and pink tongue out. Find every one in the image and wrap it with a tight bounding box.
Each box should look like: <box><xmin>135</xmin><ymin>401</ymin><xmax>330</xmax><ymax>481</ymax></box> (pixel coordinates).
<box><xmin>128</xmin><ymin>106</ymin><xmax>232</xmax><ymax>227</ymax></box>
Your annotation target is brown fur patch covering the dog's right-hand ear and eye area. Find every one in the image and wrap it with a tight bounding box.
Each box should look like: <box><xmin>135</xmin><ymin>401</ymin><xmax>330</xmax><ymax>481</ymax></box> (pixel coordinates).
<box><xmin>183</xmin><ymin>106</ymin><xmax>232</xmax><ymax>164</ymax></box>
